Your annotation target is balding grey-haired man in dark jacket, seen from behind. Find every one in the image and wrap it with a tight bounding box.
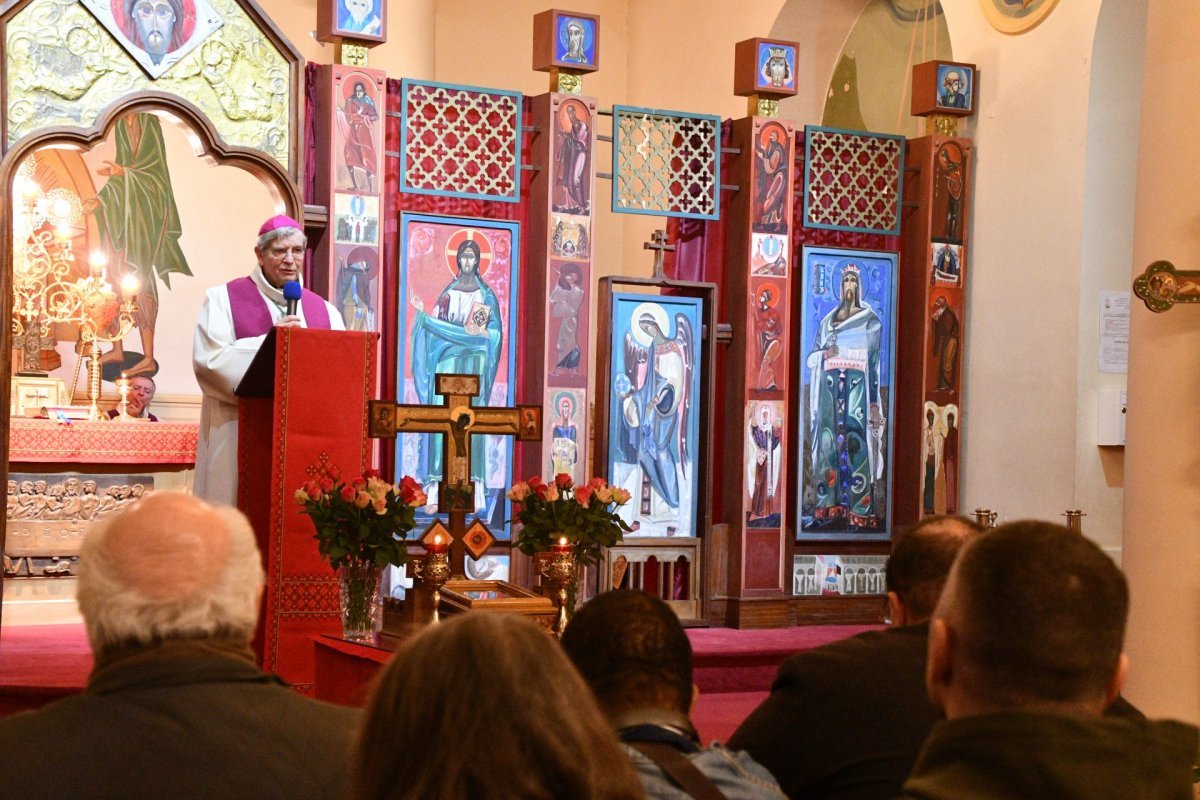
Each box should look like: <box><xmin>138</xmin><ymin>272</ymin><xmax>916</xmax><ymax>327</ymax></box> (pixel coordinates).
<box><xmin>0</xmin><ymin>492</ymin><xmax>359</xmax><ymax>800</ymax></box>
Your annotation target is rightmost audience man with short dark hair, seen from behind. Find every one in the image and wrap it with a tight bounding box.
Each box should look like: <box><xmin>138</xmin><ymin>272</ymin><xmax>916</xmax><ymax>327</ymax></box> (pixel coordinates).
<box><xmin>904</xmin><ymin>522</ymin><xmax>1198</xmax><ymax>800</ymax></box>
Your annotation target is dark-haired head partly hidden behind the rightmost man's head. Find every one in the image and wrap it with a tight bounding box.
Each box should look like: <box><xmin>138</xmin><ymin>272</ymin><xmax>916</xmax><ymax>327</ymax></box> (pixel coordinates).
<box><xmin>887</xmin><ymin>516</ymin><xmax>983</xmax><ymax>625</ymax></box>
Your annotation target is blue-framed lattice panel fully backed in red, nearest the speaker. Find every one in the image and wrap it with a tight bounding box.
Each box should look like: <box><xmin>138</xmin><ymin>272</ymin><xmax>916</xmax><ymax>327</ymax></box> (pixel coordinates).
<box><xmin>400</xmin><ymin>79</ymin><xmax>521</xmax><ymax>203</ymax></box>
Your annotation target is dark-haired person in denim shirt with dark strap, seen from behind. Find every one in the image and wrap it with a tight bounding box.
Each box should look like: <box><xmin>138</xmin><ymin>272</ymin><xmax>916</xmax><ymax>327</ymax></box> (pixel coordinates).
<box><xmin>563</xmin><ymin>589</ymin><xmax>784</xmax><ymax>800</ymax></box>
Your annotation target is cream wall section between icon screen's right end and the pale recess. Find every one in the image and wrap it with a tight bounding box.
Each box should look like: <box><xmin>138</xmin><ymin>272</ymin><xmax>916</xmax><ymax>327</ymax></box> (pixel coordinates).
<box><xmin>942</xmin><ymin>0</ymin><xmax>1120</xmax><ymax>537</ymax></box>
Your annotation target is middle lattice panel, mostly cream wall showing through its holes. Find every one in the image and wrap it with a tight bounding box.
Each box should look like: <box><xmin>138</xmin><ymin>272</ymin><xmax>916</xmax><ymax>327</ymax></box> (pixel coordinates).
<box><xmin>612</xmin><ymin>106</ymin><xmax>721</xmax><ymax>219</ymax></box>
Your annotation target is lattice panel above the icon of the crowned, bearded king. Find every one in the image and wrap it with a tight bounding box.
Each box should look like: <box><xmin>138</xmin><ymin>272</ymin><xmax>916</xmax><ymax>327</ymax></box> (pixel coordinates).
<box><xmin>804</xmin><ymin>126</ymin><xmax>904</xmax><ymax>235</ymax></box>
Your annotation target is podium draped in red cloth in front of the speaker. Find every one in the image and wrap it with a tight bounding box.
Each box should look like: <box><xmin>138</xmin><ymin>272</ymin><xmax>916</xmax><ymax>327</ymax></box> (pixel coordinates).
<box><xmin>236</xmin><ymin>327</ymin><xmax>379</xmax><ymax>694</ymax></box>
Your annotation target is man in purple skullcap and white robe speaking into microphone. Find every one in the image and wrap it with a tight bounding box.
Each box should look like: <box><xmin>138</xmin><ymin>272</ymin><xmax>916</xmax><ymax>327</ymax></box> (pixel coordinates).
<box><xmin>192</xmin><ymin>215</ymin><xmax>344</xmax><ymax>505</ymax></box>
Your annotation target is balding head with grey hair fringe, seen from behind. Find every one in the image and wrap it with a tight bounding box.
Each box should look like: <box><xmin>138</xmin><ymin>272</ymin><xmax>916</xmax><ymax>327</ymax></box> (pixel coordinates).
<box><xmin>78</xmin><ymin>492</ymin><xmax>263</xmax><ymax>654</ymax></box>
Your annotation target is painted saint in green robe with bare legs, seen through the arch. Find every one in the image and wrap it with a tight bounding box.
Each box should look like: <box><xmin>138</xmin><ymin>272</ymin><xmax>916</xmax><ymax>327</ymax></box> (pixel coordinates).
<box><xmin>84</xmin><ymin>113</ymin><xmax>192</xmax><ymax>378</ymax></box>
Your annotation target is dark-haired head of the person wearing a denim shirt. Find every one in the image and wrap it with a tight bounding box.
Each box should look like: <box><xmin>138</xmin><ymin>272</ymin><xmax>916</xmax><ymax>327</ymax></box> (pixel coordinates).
<box><xmin>563</xmin><ymin>589</ymin><xmax>692</xmax><ymax>718</ymax></box>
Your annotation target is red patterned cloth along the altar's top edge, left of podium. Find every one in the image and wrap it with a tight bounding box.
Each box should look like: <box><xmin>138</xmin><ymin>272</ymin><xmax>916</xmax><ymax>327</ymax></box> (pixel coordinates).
<box><xmin>8</xmin><ymin>417</ymin><xmax>199</xmax><ymax>464</ymax></box>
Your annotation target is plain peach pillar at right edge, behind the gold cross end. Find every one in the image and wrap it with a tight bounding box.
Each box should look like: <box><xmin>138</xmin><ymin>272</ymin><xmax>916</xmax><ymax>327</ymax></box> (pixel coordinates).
<box><xmin>1123</xmin><ymin>0</ymin><xmax>1200</xmax><ymax>722</ymax></box>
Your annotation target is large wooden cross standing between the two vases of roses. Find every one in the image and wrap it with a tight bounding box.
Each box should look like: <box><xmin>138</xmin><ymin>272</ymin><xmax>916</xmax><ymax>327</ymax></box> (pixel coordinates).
<box><xmin>367</xmin><ymin>373</ymin><xmax>541</xmax><ymax>578</ymax></box>
